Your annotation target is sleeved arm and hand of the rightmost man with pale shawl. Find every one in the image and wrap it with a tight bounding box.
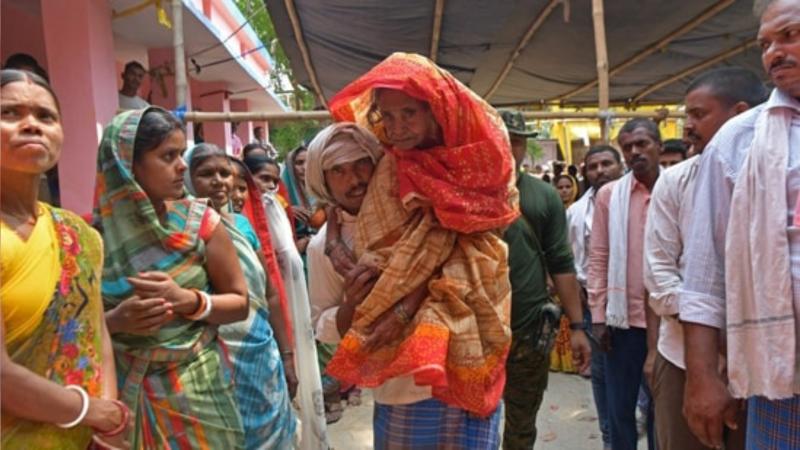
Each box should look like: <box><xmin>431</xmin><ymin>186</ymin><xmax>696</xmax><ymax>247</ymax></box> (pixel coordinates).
<box><xmin>679</xmin><ymin>140</ymin><xmax>737</xmax><ymax>447</ymax></box>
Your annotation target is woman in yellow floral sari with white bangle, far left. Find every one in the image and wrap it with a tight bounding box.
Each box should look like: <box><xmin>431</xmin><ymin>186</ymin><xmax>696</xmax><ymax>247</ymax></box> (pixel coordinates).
<box><xmin>0</xmin><ymin>70</ymin><xmax>130</xmax><ymax>450</ymax></box>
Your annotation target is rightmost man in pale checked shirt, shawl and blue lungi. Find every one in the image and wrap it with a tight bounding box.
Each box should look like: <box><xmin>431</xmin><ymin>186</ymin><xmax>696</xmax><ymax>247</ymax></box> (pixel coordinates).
<box><xmin>679</xmin><ymin>0</ymin><xmax>800</xmax><ymax>449</ymax></box>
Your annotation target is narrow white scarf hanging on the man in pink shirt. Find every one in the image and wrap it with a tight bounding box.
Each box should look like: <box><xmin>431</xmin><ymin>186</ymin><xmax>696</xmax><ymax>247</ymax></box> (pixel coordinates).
<box><xmin>606</xmin><ymin>172</ymin><xmax>633</xmax><ymax>329</ymax></box>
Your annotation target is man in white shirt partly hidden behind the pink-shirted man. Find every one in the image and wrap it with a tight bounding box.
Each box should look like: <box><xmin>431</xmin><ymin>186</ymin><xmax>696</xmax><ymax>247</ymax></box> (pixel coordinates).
<box><xmin>567</xmin><ymin>145</ymin><xmax>625</xmax><ymax>448</ymax></box>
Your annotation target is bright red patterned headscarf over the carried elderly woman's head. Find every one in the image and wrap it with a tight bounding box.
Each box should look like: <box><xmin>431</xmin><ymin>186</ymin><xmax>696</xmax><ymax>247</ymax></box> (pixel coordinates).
<box><xmin>330</xmin><ymin>53</ymin><xmax>519</xmax><ymax>233</ymax></box>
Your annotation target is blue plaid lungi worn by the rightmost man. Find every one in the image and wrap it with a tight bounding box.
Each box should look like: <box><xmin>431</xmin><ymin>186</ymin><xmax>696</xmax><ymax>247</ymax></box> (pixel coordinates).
<box><xmin>747</xmin><ymin>395</ymin><xmax>800</xmax><ymax>450</ymax></box>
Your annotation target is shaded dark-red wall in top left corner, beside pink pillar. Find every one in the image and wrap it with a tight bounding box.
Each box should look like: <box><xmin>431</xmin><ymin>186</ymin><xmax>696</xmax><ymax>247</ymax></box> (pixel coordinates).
<box><xmin>0</xmin><ymin>0</ymin><xmax>49</xmax><ymax>72</ymax></box>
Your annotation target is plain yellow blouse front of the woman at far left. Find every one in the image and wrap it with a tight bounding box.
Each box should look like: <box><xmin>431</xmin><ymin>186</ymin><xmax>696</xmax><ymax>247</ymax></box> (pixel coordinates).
<box><xmin>0</xmin><ymin>203</ymin><xmax>61</xmax><ymax>345</ymax></box>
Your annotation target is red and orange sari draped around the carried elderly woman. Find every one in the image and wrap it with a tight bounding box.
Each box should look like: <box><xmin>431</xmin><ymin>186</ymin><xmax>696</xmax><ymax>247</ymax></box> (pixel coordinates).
<box><xmin>328</xmin><ymin>54</ymin><xmax>518</xmax><ymax>416</ymax></box>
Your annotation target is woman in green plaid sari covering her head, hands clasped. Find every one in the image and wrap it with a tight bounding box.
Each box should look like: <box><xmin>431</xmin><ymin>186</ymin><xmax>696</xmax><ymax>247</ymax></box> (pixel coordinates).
<box><xmin>95</xmin><ymin>108</ymin><xmax>249</xmax><ymax>449</ymax></box>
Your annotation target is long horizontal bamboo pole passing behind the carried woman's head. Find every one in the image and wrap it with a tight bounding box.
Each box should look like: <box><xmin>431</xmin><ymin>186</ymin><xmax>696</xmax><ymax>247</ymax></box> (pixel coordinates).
<box><xmin>184</xmin><ymin>110</ymin><xmax>686</xmax><ymax>122</ymax></box>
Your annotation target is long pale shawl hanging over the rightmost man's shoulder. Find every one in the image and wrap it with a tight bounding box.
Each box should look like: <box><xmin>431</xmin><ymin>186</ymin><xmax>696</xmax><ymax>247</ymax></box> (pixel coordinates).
<box><xmin>725</xmin><ymin>106</ymin><xmax>796</xmax><ymax>399</ymax></box>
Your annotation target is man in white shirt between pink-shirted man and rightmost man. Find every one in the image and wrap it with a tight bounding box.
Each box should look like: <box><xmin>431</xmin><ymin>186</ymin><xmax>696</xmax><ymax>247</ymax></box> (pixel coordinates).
<box><xmin>644</xmin><ymin>68</ymin><xmax>768</xmax><ymax>450</ymax></box>
